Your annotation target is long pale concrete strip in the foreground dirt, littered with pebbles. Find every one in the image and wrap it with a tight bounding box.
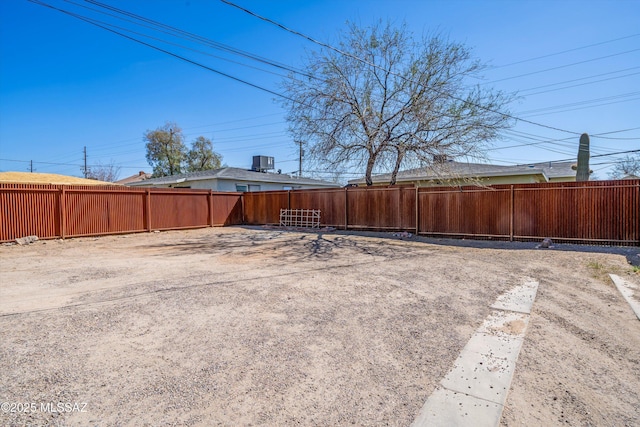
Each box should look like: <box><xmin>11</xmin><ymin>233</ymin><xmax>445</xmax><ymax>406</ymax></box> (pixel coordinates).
<box><xmin>412</xmin><ymin>281</ymin><xmax>538</xmax><ymax>427</ymax></box>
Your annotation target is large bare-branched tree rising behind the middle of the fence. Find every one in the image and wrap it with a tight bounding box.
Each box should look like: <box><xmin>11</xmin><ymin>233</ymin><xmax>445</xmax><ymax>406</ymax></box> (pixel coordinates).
<box><xmin>283</xmin><ymin>24</ymin><xmax>512</xmax><ymax>185</ymax></box>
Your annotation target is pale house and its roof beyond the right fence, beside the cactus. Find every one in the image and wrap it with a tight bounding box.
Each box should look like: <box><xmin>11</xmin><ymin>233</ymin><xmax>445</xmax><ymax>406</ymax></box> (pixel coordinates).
<box><xmin>349</xmin><ymin>161</ymin><xmax>576</xmax><ymax>187</ymax></box>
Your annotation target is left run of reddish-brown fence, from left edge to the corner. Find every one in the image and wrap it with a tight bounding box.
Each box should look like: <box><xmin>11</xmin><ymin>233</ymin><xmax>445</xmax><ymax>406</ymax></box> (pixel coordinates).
<box><xmin>0</xmin><ymin>184</ymin><xmax>242</xmax><ymax>241</ymax></box>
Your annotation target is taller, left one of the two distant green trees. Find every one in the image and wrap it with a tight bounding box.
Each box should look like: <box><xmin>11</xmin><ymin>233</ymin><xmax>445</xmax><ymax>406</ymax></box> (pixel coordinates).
<box><xmin>144</xmin><ymin>122</ymin><xmax>187</xmax><ymax>177</ymax></box>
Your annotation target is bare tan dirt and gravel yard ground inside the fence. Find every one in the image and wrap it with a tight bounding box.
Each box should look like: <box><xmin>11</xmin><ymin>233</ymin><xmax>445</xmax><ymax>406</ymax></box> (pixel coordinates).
<box><xmin>0</xmin><ymin>227</ymin><xmax>640</xmax><ymax>426</ymax></box>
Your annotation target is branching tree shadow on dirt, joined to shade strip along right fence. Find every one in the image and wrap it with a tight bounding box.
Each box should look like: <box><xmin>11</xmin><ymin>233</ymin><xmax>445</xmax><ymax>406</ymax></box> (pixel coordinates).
<box><xmin>138</xmin><ymin>226</ymin><xmax>640</xmax><ymax>266</ymax></box>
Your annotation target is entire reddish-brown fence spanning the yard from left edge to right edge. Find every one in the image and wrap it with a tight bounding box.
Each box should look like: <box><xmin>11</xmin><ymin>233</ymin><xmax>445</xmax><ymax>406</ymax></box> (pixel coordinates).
<box><xmin>0</xmin><ymin>180</ymin><xmax>640</xmax><ymax>246</ymax></box>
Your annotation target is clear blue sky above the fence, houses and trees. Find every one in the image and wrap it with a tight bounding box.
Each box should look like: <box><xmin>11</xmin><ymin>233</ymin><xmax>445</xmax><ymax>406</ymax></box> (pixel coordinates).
<box><xmin>0</xmin><ymin>0</ymin><xmax>640</xmax><ymax>179</ymax></box>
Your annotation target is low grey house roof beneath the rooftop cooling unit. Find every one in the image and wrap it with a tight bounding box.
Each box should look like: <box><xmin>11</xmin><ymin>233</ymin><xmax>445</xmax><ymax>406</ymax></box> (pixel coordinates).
<box><xmin>127</xmin><ymin>167</ymin><xmax>339</xmax><ymax>187</ymax></box>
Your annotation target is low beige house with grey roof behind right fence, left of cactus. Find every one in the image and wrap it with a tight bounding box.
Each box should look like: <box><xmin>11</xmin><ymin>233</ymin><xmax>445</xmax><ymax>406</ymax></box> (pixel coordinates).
<box><xmin>349</xmin><ymin>161</ymin><xmax>576</xmax><ymax>184</ymax></box>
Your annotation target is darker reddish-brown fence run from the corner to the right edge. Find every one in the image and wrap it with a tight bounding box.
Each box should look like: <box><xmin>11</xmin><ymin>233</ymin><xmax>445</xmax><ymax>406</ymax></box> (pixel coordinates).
<box><xmin>244</xmin><ymin>180</ymin><xmax>640</xmax><ymax>245</ymax></box>
